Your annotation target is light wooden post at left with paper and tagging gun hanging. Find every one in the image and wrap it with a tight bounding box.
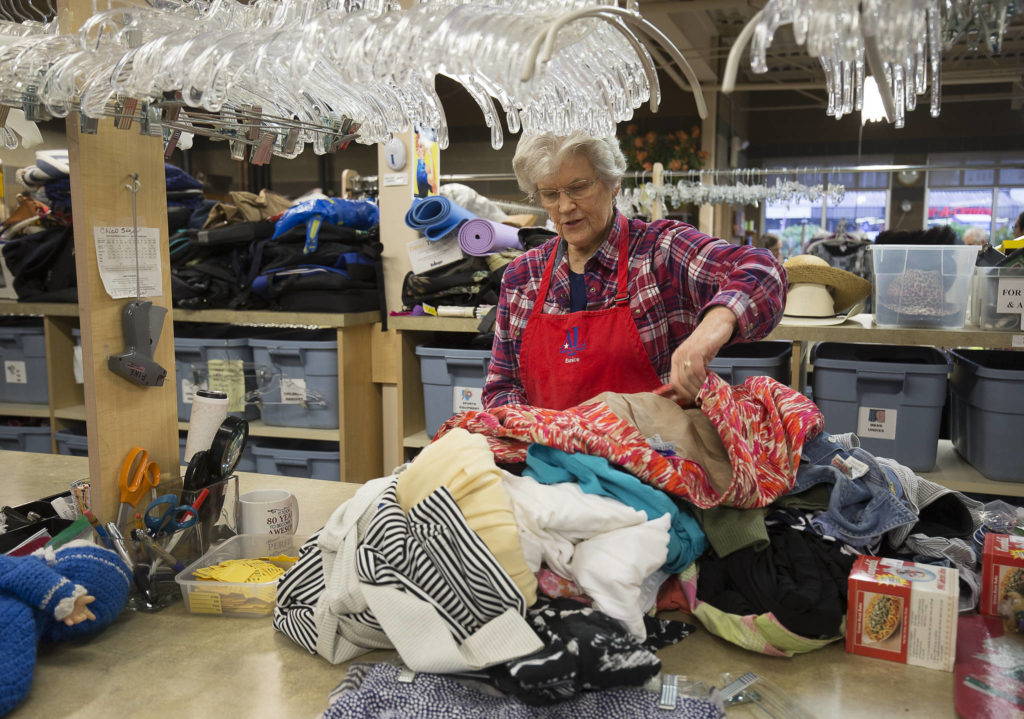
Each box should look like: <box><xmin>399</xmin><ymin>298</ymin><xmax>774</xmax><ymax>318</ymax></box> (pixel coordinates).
<box><xmin>58</xmin><ymin>0</ymin><xmax>179</xmax><ymax>521</ymax></box>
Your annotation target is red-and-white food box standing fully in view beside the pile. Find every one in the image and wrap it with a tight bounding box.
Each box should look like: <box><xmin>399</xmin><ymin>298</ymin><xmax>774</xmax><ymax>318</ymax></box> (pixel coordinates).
<box><xmin>846</xmin><ymin>556</ymin><xmax>959</xmax><ymax>672</ymax></box>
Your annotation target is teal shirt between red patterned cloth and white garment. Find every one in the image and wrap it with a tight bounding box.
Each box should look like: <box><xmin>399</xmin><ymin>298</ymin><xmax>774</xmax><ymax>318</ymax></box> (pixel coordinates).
<box><xmin>523</xmin><ymin>445</ymin><xmax>708</xmax><ymax>575</ymax></box>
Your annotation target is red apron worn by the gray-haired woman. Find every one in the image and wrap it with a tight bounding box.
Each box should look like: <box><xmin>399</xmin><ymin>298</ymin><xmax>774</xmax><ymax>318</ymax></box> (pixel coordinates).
<box><xmin>519</xmin><ymin>232</ymin><xmax>662</xmax><ymax>410</ymax></box>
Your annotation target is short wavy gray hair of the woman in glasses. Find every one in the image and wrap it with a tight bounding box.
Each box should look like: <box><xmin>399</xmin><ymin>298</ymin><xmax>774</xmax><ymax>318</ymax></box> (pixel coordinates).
<box><xmin>512</xmin><ymin>132</ymin><xmax>626</xmax><ymax>197</ymax></box>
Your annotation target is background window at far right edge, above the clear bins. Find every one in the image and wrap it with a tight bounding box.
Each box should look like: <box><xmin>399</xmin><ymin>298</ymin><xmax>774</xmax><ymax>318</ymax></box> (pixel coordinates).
<box><xmin>928</xmin><ymin>153</ymin><xmax>1024</xmax><ymax>244</ymax></box>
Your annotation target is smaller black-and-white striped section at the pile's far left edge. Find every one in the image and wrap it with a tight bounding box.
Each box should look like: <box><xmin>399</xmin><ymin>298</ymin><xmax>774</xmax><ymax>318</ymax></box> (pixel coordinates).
<box><xmin>273</xmin><ymin>527</ymin><xmax>326</xmax><ymax>654</ymax></box>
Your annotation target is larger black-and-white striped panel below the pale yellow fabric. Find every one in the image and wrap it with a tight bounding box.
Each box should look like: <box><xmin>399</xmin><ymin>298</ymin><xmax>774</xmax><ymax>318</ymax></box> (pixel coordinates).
<box><xmin>355</xmin><ymin>483</ymin><xmax>526</xmax><ymax>642</ymax></box>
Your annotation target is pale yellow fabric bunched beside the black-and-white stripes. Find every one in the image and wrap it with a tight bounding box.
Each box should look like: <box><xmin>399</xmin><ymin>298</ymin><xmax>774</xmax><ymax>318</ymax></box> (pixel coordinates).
<box><xmin>395</xmin><ymin>428</ymin><xmax>537</xmax><ymax>606</ymax></box>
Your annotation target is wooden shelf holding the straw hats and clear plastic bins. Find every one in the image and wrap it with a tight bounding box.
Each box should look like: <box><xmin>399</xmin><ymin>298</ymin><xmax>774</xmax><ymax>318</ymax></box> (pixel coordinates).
<box><xmin>765</xmin><ymin>314</ymin><xmax>1024</xmax><ymax>348</ymax></box>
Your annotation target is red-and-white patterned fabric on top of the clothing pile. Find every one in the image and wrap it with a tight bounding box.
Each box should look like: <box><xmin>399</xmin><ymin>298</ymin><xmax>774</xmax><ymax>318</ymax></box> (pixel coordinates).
<box><xmin>434</xmin><ymin>372</ymin><xmax>824</xmax><ymax>509</ymax></box>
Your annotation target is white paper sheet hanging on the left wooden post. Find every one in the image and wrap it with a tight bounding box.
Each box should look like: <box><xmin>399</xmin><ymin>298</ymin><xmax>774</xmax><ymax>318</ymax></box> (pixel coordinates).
<box><xmin>92</xmin><ymin>227</ymin><xmax>164</xmax><ymax>299</ymax></box>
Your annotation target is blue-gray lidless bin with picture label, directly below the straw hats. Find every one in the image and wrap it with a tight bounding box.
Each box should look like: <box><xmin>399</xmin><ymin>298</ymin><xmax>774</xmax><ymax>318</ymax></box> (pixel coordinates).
<box><xmin>812</xmin><ymin>342</ymin><xmax>950</xmax><ymax>472</ymax></box>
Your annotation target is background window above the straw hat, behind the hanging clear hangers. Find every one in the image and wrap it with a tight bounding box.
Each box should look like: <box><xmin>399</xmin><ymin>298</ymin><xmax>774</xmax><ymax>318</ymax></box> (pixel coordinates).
<box><xmin>762</xmin><ymin>156</ymin><xmax>892</xmax><ymax>258</ymax></box>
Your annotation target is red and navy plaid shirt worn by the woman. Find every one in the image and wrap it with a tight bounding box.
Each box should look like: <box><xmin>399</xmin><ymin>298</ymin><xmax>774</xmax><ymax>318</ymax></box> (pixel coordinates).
<box><xmin>483</xmin><ymin>211</ymin><xmax>786</xmax><ymax>408</ymax></box>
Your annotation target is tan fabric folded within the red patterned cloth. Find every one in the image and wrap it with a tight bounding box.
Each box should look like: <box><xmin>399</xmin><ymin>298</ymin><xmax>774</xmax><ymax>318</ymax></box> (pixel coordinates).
<box><xmin>588</xmin><ymin>392</ymin><xmax>732</xmax><ymax>494</ymax></box>
